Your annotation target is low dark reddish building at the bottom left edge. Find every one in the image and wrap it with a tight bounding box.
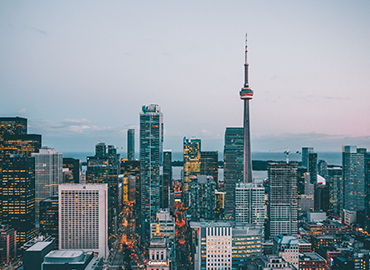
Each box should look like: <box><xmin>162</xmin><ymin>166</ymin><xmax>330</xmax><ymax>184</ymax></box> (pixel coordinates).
<box><xmin>0</xmin><ymin>224</ymin><xmax>17</xmax><ymax>264</ymax></box>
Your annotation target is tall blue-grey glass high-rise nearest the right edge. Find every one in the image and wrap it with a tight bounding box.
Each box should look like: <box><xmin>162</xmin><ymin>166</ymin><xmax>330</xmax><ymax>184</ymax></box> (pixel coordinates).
<box><xmin>342</xmin><ymin>145</ymin><xmax>365</xmax><ymax>212</ymax></box>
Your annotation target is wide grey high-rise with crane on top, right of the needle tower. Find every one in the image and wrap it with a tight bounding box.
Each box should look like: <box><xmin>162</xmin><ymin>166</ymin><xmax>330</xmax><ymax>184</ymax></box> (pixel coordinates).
<box><xmin>267</xmin><ymin>163</ymin><xmax>298</xmax><ymax>239</ymax></box>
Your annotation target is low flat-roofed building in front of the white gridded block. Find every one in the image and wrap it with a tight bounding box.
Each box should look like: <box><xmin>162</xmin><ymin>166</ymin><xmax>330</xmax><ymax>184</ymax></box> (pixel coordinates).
<box><xmin>42</xmin><ymin>249</ymin><xmax>103</xmax><ymax>270</ymax></box>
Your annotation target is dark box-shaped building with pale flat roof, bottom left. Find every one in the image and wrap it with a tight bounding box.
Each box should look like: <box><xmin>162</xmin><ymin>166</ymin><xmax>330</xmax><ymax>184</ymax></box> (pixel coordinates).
<box><xmin>23</xmin><ymin>237</ymin><xmax>55</xmax><ymax>270</ymax></box>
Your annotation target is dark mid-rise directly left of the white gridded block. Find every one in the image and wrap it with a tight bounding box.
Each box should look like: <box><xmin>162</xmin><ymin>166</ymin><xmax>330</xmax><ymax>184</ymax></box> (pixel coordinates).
<box><xmin>40</xmin><ymin>195</ymin><xmax>59</xmax><ymax>246</ymax></box>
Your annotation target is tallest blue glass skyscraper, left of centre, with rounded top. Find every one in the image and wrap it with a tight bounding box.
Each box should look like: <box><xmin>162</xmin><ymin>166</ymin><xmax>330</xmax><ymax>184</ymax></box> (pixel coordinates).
<box><xmin>140</xmin><ymin>104</ymin><xmax>163</xmax><ymax>240</ymax></box>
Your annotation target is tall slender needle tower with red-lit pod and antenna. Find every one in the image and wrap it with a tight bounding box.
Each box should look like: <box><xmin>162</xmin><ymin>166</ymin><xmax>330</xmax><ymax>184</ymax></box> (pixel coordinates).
<box><xmin>240</xmin><ymin>34</ymin><xmax>253</xmax><ymax>183</ymax></box>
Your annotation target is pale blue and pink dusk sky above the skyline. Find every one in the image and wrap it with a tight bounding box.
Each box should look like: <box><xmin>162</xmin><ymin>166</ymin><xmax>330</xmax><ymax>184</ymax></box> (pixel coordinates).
<box><xmin>0</xmin><ymin>0</ymin><xmax>370</xmax><ymax>155</ymax></box>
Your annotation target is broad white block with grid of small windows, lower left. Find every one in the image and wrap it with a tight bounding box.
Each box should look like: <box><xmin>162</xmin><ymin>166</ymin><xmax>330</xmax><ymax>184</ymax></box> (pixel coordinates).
<box><xmin>59</xmin><ymin>184</ymin><xmax>108</xmax><ymax>257</ymax></box>
